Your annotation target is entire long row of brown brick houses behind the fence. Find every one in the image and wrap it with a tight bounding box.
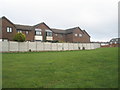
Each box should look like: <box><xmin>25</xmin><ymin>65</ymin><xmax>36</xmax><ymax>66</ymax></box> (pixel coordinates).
<box><xmin>0</xmin><ymin>17</ymin><xmax>90</xmax><ymax>42</ymax></box>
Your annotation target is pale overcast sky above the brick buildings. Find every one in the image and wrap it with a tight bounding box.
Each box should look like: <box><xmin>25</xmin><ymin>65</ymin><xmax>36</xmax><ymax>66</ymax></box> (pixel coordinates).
<box><xmin>0</xmin><ymin>0</ymin><xmax>119</xmax><ymax>41</ymax></box>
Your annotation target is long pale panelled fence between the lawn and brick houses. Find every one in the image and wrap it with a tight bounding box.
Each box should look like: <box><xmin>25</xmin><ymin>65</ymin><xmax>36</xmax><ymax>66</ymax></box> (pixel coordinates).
<box><xmin>0</xmin><ymin>41</ymin><xmax>100</xmax><ymax>52</ymax></box>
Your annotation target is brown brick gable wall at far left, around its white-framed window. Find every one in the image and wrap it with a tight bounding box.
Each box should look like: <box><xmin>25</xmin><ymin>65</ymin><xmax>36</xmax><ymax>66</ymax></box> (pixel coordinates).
<box><xmin>2</xmin><ymin>18</ymin><xmax>16</xmax><ymax>40</ymax></box>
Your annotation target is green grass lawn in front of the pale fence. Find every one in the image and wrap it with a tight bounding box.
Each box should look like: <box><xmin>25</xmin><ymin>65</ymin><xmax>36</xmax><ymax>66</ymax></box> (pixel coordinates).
<box><xmin>2</xmin><ymin>48</ymin><xmax>118</xmax><ymax>88</ymax></box>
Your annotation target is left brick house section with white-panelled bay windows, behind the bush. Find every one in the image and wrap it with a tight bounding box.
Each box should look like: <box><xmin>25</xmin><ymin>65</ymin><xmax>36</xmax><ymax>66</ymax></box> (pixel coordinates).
<box><xmin>0</xmin><ymin>17</ymin><xmax>53</xmax><ymax>41</ymax></box>
